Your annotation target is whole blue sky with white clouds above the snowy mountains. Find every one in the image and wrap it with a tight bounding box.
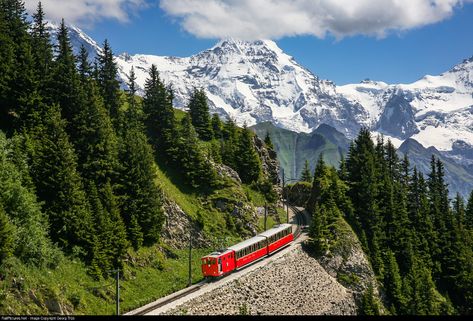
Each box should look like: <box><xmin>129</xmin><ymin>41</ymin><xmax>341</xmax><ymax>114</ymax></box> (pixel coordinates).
<box><xmin>26</xmin><ymin>0</ymin><xmax>473</xmax><ymax>85</ymax></box>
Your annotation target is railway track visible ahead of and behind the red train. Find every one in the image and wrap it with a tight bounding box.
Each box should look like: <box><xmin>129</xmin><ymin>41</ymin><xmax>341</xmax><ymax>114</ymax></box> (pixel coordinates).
<box><xmin>126</xmin><ymin>205</ymin><xmax>307</xmax><ymax>315</ymax></box>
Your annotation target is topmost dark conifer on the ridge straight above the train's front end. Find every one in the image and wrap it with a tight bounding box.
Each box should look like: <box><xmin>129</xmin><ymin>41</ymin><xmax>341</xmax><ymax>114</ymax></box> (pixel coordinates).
<box><xmin>188</xmin><ymin>88</ymin><xmax>212</xmax><ymax>140</ymax></box>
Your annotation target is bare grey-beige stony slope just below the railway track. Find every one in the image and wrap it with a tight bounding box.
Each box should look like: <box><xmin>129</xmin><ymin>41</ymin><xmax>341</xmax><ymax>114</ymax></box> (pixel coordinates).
<box><xmin>167</xmin><ymin>245</ymin><xmax>356</xmax><ymax>315</ymax></box>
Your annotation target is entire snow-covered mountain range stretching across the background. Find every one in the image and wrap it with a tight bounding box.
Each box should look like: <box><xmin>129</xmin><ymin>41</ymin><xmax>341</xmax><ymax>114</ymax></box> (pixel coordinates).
<box><xmin>53</xmin><ymin>25</ymin><xmax>473</xmax><ymax>164</ymax></box>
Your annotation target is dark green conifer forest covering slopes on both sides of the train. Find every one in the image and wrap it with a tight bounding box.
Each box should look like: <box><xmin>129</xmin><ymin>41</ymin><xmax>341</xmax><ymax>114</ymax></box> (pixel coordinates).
<box><xmin>0</xmin><ymin>0</ymin><xmax>473</xmax><ymax>315</ymax></box>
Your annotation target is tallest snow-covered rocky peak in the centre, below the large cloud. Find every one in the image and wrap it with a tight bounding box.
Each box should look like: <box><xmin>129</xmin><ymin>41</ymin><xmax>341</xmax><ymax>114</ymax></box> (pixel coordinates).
<box><xmin>116</xmin><ymin>39</ymin><xmax>369</xmax><ymax>136</ymax></box>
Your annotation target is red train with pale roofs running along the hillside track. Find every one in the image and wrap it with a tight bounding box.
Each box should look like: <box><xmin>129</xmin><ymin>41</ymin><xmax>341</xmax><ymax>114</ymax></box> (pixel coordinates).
<box><xmin>202</xmin><ymin>224</ymin><xmax>294</xmax><ymax>277</ymax></box>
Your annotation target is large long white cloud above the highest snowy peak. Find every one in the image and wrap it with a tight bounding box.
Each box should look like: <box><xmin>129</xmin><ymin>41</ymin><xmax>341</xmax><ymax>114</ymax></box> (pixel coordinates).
<box><xmin>160</xmin><ymin>0</ymin><xmax>473</xmax><ymax>40</ymax></box>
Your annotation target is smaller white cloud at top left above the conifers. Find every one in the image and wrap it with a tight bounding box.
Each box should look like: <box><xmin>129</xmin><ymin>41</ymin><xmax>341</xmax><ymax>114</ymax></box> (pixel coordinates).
<box><xmin>25</xmin><ymin>0</ymin><xmax>147</xmax><ymax>27</ymax></box>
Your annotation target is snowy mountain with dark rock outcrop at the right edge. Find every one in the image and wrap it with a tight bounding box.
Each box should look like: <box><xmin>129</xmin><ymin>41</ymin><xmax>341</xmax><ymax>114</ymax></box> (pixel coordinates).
<box><xmin>337</xmin><ymin>57</ymin><xmax>473</xmax><ymax>151</ymax></box>
